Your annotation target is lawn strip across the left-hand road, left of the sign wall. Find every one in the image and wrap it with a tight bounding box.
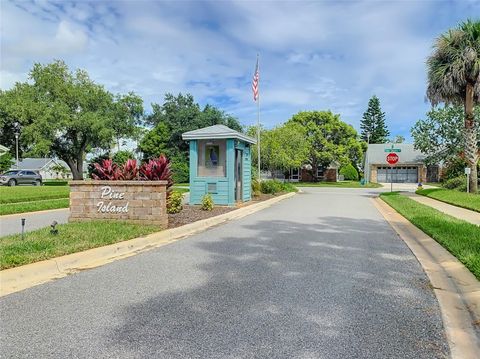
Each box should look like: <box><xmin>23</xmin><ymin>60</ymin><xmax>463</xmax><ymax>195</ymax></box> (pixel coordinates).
<box><xmin>0</xmin><ymin>186</ymin><xmax>70</xmax><ymax>204</ymax></box>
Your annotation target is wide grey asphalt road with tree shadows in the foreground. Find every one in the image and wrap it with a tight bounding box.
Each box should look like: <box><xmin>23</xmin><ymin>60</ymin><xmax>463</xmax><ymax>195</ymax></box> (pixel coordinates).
<box><xmin>0</xmin><ymin>188</ymin><xmax>448</xmax><ymax>359</ymax></box>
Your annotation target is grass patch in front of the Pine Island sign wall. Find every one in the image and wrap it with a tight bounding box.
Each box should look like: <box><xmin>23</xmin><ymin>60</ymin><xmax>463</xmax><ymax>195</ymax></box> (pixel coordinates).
<box><xmin>0</xmin><ymin>221</ymin><xmax>160</xmax><ymax>269</ymax></box>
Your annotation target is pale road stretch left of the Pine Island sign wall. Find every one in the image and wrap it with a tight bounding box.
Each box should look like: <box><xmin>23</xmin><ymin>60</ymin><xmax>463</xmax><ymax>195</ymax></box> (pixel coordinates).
<box><xmin>0</xmin><ymin>208</ymin><xmax>69</xmax><ymax>236</ymax></box>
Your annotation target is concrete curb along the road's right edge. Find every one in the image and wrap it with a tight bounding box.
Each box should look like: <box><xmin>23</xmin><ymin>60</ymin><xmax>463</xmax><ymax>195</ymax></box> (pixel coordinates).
<box><xmin>372</xmin><ymin>198</ymin><xmax>480</xmax><ymax>359</ymax></box>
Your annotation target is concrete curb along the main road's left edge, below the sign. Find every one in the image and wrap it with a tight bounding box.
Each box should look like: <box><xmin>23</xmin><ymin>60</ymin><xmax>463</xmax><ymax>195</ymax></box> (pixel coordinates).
<box><xmin>0</xmin><ymin>192</ymin><xmax>295</xmax><ymax>297</ymax></box>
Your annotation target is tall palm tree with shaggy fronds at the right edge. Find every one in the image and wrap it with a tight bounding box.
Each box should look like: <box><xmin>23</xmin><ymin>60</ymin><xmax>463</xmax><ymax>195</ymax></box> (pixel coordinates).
<box><xmin>427</xmin><ymin>20</ymin><xmax>480</xmax><ymax>193</ymax></box>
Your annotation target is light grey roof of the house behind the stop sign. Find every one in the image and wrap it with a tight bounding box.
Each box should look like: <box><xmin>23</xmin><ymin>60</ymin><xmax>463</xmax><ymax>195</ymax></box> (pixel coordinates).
<box><xmin>366</xmin><ymin>143</ymin><xmax>425</xmax><ymax>164</ymax></box>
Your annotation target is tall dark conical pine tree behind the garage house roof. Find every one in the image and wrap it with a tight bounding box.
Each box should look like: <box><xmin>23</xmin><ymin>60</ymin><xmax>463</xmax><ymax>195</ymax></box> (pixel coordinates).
<box><xmin>360</xmin><ymin>95</ymin><xmax>390</xmax><ymax>143</ymax></box>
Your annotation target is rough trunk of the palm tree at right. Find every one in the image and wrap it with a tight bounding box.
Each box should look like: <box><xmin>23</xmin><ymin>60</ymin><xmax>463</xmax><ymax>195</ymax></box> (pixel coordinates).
<box><xmin>465</xmin><ymin>84</ymin><xmax>479</xmax><ymax>193</ymax></box>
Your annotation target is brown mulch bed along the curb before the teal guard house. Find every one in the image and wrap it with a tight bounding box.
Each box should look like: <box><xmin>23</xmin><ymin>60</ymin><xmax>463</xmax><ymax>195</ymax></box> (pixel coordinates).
<box><xmin>168</xmin><ymin>193</ymin><xmax>284</xmax><ymax>228</ymax></box>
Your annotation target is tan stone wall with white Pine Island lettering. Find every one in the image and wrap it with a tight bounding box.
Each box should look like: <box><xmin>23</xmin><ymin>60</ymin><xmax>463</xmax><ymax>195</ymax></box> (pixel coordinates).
<box><xmin>69</xmin><ymin>181</ymin><xmax>168</xmax><ymax>227</ymax></box>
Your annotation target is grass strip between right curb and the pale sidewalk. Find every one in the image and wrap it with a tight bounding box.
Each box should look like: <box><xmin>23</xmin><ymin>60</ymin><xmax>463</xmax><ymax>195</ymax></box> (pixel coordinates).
<box><xmin>380</xmin><ymin>192</ymin><xmax>480</xmax><ymax>279</ymax></box>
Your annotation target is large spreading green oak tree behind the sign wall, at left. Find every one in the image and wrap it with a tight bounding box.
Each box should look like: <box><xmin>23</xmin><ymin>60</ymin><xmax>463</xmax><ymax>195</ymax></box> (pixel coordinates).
<box><xmin>0</xmin><ymin>61</ymin><xmax>143</xmax><ymax>183</ymax></box>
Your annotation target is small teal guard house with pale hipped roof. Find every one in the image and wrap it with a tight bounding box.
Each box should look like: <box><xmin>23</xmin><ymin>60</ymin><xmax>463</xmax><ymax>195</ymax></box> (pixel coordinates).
<box><xmin>182</xmin><ymin>125</ymin><xmax>256</xmax><ymax>206</ymax></box>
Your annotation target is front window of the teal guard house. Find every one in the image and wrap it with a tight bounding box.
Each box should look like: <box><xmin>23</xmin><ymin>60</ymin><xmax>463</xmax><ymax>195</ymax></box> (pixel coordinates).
<box><xmin>198</xmin><ymin>140</ymin><xmax>226</xmax><ymax>177</ymax></box>
